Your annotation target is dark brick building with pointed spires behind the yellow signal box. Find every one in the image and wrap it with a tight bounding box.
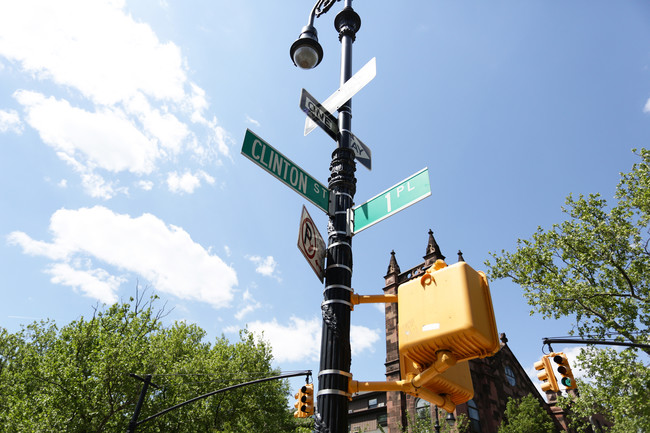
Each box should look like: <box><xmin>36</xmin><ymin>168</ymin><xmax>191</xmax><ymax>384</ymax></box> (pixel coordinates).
<box><xmin>348</xmin><ymin>231</ymin><xmax>566</xmax><ymax>433</ymax></box>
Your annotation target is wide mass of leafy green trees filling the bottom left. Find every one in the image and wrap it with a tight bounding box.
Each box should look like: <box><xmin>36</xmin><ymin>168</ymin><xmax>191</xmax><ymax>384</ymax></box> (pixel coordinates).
<box><xmin>0</xmin><ymin>292</ymin><xmax>294</xmax><ymax>433</ymax></box>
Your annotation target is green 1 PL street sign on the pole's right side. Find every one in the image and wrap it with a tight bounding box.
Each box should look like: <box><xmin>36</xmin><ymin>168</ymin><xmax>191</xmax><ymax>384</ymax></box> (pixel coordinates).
<box><xmin>352</xmin><ymin>168</ymin><xmax>431</xmax><ymax>234</ymax></box>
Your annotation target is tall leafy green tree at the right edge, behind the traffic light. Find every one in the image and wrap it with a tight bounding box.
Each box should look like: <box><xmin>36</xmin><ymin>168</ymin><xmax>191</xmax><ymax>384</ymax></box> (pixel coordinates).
<box><xmin>486</xmin><ymin>149</ymin><xmax>650</xmax><ymax>432</ymax></box>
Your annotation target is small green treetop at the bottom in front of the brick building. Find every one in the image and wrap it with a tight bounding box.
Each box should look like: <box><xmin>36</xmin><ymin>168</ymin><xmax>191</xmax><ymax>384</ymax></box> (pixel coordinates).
<box><xmin>499</xmin><ymin>394</ymin><xmax>557</xmax><ymax>433</ymax></box>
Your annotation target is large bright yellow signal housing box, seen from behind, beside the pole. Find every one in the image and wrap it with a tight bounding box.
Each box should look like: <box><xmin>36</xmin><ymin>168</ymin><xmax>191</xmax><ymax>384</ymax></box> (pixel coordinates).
<box><xmin>397</xmin><ymin>260</ymin><xmax>501</xmax><ymax>372</ymax></box>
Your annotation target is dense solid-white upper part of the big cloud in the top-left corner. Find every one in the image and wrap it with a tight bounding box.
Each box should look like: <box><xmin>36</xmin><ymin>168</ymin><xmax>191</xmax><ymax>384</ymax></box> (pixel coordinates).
<box><xmin>0</xmin><ymin>0</ymin><xmax>186</xmax><ymax>105</ymax></box>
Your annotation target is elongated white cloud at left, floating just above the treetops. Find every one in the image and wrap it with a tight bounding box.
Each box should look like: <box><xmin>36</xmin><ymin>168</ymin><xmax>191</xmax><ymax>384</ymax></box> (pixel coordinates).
<box><xmin>8</xmin><ymin>206</ymin><xmax>237</xmax><ymax>308</ymax></box>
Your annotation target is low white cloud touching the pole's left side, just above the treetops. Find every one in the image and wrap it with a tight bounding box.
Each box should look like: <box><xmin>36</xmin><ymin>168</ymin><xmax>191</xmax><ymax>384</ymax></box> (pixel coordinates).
<box><xmin>248</xmin><ymin>316</ymin><xmax>321</xmax><ymax>362</ymax></box>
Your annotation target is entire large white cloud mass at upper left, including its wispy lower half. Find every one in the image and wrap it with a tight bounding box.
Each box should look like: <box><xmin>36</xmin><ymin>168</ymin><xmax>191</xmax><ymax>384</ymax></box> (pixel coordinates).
<box><xmin>0</xmin><ymin>0</ymin><xmax>232</xmax><ymax>199</ymax></box>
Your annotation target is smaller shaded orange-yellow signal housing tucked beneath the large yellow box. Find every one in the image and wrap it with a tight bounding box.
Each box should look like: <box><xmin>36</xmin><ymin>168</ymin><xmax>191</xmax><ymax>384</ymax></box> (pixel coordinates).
<box><xmin>402</xmin><ymin>354</ymin><xmax>474</xmax><ymax>405</ymax></box>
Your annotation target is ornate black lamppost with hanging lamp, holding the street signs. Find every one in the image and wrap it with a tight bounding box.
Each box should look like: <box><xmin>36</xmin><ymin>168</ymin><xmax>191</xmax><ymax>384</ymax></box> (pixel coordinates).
<box><xmin>290</xmin><ymin>0</ymin><xmax>361</xmax><ymax>433</ymax></box>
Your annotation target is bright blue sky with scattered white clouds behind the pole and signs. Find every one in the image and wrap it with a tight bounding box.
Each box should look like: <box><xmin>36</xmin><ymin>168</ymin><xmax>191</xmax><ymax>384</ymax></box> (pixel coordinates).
<box><xmin>0</xmin><ymin>0</ymin><xmax>650</xmax><ymax>396</ymax></box>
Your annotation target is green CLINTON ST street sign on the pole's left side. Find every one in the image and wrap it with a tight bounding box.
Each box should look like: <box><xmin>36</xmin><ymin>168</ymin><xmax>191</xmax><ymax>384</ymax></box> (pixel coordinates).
<box><xmin>241</xmin><ymin>129</ymin><xmax>330</xmax><ymax>213</ymax></box>
